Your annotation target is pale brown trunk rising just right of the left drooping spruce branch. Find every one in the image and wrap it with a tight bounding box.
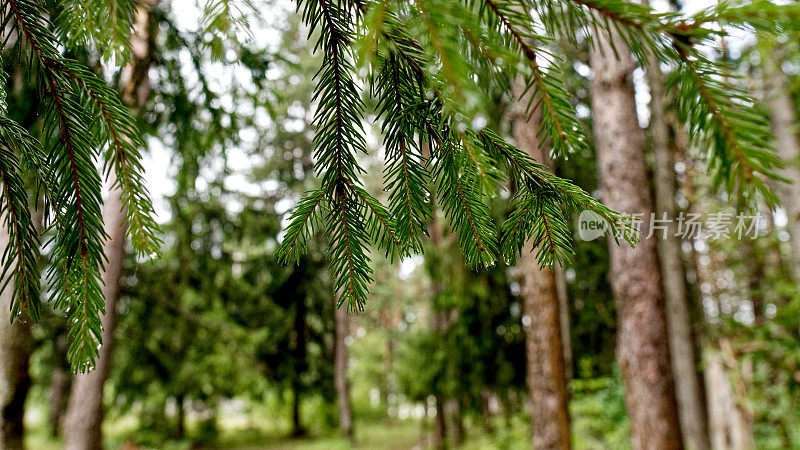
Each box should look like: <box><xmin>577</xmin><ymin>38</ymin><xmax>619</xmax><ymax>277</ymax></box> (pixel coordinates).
<box><xmin>64</xmin><ymin>0</ymin><xmax>158</xmax><ymax>450</ymax></box>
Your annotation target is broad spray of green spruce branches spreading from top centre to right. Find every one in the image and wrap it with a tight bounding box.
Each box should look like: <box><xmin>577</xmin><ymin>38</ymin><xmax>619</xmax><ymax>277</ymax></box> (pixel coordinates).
<box><xmin>284</xmin><ymin>0</ymin><xmax>788</xmax><ymax>309</ymax></box>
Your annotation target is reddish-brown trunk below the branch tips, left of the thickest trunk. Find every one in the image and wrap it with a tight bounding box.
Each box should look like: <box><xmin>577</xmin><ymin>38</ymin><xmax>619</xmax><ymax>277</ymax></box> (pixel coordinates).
<box><xmin>514</xmin><ymin>79</ymin><xmax>570</xmax><ymax>449</ymax></box>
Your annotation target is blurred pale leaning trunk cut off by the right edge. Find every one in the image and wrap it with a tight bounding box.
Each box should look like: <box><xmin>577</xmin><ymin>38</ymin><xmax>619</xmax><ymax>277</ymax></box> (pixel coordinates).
<box><xmin>761</xmin><ymin>44</ymin><xmax>800</xmax><ymax>268</ymax></box>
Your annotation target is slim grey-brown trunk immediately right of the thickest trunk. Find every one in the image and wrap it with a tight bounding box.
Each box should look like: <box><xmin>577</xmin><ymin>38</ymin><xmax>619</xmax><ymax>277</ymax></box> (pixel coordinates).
<box><xmin>647</xmin><ymin>35</ymin><xmax>711</xmax><ymax>450</ymax></box>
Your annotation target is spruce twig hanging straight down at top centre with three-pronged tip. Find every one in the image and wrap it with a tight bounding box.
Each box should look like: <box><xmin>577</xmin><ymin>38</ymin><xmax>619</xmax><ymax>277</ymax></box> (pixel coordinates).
<box><xmin>280</xmin><ymin>0</ymin><xmax>394</xmax><ymax>311</ymax></box>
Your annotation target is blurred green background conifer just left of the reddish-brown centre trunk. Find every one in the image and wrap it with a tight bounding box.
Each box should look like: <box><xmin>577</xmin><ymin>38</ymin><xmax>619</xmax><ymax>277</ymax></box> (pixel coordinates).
<box><xmin>397</xmin><ymin>221</ymin><xmax>525</xmax><ymax>445</ymax></box>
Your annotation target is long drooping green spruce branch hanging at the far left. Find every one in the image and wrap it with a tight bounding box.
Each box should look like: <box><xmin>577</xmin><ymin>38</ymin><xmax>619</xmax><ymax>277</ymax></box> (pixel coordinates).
<box><xmin>0</xmin><ymin>0</ymin><xmax>158</xmax><ymax>371</ymax></box>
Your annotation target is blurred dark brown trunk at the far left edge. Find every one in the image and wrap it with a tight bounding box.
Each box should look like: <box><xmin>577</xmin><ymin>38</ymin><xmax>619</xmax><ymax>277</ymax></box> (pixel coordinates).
<box><xmin>0</xmin><ymin>227</ymin><xmax>31</xmax><ymax>450</ymax></box>
